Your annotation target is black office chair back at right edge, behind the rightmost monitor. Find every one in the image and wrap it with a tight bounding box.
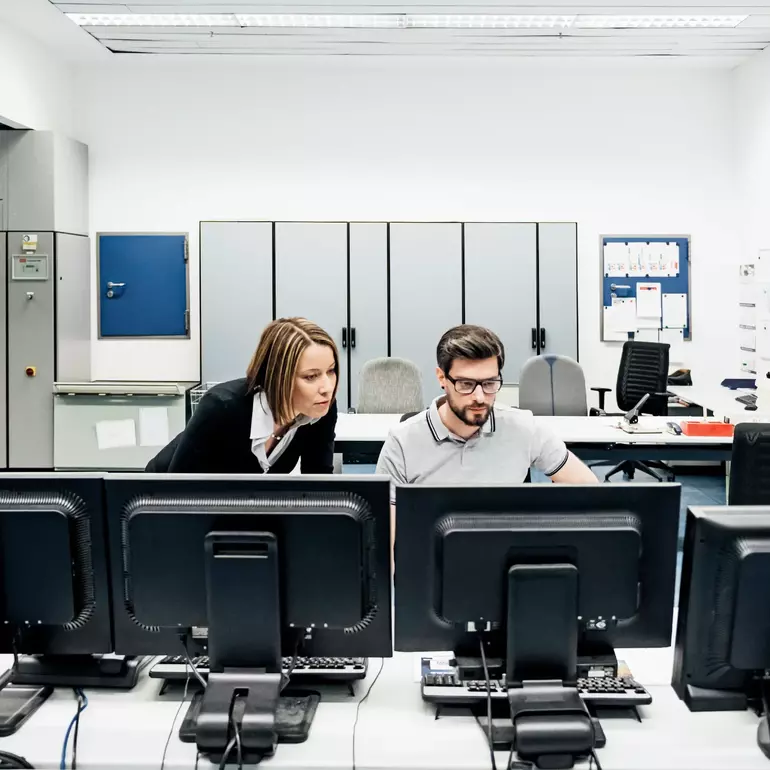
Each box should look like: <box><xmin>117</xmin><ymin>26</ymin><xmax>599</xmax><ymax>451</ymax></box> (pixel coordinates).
<box><xmin>728</xmin><ymin>422</ymin><xmax>770</xmax><ymax>505</ymax></box>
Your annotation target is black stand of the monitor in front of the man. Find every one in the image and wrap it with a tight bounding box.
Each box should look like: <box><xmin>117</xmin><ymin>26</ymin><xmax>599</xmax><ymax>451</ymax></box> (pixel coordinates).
<box><xmin>506</xmin><ymin>564</ymin><xmax>596</xmax><ymax>770</ymax></box>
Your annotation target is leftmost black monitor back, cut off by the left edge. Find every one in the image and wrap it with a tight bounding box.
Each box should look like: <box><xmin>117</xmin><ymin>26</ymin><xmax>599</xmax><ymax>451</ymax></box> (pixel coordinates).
<box><xmin>0</xmin><ymin>473</ymin><xmax>112</xmax><ymax>655</ymax></box>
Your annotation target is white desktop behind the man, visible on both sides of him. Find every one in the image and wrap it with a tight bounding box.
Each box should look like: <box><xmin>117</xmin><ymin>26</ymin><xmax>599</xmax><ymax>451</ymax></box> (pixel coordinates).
<box><xmin>336</xmin><ymin>414</ymin><xmax>732</xmax><ymax>445</ymax></box>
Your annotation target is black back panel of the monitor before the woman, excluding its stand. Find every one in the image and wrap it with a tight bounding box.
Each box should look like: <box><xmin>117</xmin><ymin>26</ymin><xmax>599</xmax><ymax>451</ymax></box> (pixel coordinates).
<box><xmin>106</xmin><ymin>473</ymin><xmax>392</xmax><ymax>657</ymax></box>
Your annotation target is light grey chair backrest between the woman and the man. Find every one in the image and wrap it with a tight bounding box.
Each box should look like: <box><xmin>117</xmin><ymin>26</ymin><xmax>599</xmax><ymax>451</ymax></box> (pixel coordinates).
<box><xmin>356</xmin><ymin>358</ymin><xmax>425</xmax><ymax>414</ymax></box>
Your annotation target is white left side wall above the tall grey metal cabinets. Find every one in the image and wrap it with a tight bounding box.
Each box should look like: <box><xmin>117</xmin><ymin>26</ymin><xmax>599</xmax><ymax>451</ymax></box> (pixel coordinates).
<box><xmin>0</xmin><ymin>19</ymin><xmax>76</xmax><ymax>138</ymax></box>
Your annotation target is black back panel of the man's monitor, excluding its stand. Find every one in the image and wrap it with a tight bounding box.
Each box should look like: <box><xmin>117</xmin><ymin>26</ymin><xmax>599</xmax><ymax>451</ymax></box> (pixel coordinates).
<box><xmin>395</xmin><ymin>484</ymin><xmax>680</xmax><ymax>651</ymax></box>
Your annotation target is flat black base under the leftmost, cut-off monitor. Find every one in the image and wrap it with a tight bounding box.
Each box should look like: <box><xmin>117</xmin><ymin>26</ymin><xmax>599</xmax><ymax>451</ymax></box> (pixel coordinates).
<box><xmin>11</xmin><ymin>655</ymin><xmax>150</xmax><ymax>690</ymax></box>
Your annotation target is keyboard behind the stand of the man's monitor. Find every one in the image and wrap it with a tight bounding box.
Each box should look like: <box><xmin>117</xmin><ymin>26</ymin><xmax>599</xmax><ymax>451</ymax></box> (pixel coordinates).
<box><xmin>422</xmin><ymin>673</ymin><xmax>652</xmax><ymax>708</ymax></box>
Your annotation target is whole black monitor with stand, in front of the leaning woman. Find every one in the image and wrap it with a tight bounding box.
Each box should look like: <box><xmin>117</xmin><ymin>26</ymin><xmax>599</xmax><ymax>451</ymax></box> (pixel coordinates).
<box><xmin>106</xmin><ymin>473</ymin><xmax>392</xmax><ymax>762</ymax></box>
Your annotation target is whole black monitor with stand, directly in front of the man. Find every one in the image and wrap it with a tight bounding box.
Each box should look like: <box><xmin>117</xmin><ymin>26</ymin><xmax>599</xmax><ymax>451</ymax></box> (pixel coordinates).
<box><xmin>395</xmin><ymin>484</ymin><xmax>680</xmax><ymax>767</ymax></box>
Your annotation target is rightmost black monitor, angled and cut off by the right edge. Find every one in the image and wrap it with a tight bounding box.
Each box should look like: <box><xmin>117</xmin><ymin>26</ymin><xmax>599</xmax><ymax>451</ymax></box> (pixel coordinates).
<box><xmin>672</xmin><ymin>506</ymin><xmax>770</xmax><ymax>711</ymax></box>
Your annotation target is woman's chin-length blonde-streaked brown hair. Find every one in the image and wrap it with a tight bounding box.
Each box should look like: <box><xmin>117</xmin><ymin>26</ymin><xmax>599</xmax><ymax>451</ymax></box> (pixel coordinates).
<box><xmin>246</xmin><ymin>318</ymin><xmax>340</xmax><ymax>425</ymax></box>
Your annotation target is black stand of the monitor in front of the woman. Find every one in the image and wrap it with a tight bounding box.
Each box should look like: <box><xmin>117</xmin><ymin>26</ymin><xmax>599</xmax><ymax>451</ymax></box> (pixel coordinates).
<box><xmin>196</xmin><ymin>532</ymin><xmax>317</xmax><ymax>764</ymax></box>
